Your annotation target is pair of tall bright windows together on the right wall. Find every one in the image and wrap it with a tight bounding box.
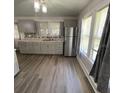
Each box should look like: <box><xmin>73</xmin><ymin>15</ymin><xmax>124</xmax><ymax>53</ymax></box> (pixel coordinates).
<box><xmin>80</xmin><ymin>7</ymin><xmax>108</xmax><ymax>63</ymax></box>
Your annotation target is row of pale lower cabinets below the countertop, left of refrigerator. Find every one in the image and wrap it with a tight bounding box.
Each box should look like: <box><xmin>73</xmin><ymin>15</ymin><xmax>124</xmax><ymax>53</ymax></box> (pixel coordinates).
<box><xmin>19</xmin><ymin>41</ymin><xmax>63</xmax><ymax>54</ymax></box>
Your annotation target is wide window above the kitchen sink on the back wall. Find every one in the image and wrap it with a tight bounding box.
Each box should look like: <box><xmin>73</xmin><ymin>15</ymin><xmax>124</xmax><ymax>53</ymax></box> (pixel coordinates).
<box><xmin>40</xmin><ymin>22</ymin><xmax>60</xmax><ymax>37</ymax></box>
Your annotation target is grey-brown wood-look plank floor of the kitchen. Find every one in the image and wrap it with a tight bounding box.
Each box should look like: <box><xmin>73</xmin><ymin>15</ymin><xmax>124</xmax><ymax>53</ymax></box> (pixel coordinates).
<box><xmin>14</xmin><ymin>53</ymin><xmax>93</xmax><ymax>93</ymax></box>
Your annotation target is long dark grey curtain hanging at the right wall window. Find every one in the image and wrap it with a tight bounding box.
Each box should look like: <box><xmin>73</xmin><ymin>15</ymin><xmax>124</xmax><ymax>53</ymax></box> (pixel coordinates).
<box><xmin>90</xmin><ymin>7</ymin><xmax>110</xmax><ymax>93</ymax></box>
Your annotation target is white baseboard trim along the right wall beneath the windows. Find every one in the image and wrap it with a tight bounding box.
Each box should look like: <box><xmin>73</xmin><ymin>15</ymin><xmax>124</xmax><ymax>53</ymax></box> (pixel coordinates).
<box><xmin>76</xmin><ymin>55</ymin><xmax>100</xmax><ymax>93</ymax></box>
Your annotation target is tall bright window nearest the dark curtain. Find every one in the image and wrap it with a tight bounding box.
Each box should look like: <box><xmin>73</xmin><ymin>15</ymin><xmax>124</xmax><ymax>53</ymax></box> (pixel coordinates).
<box><xmin>90</xmin><ymin>7</ymin><xmax>108</xmax><ymax>61</ymax></box>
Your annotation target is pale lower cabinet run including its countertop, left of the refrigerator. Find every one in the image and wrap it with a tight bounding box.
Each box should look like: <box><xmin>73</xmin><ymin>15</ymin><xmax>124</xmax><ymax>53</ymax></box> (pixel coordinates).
<box><xmin>19</xmin><ymin>38</ymin><xmax>64</xmax><ymax>54</ymax></box>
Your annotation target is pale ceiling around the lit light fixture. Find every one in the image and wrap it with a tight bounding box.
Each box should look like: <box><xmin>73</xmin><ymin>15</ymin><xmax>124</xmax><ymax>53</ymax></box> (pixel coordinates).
<box><xmin>14</xmin><ymin>0</ymin><xmax>90</xmax><ymax>17</ymax></box>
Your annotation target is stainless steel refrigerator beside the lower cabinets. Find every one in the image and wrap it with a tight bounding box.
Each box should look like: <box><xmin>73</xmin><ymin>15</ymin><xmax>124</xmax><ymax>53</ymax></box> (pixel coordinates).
<box><xmin>64</xmin><ymin>27</ymin><xmax>78</xmax><ymax>56</ymax></box>
